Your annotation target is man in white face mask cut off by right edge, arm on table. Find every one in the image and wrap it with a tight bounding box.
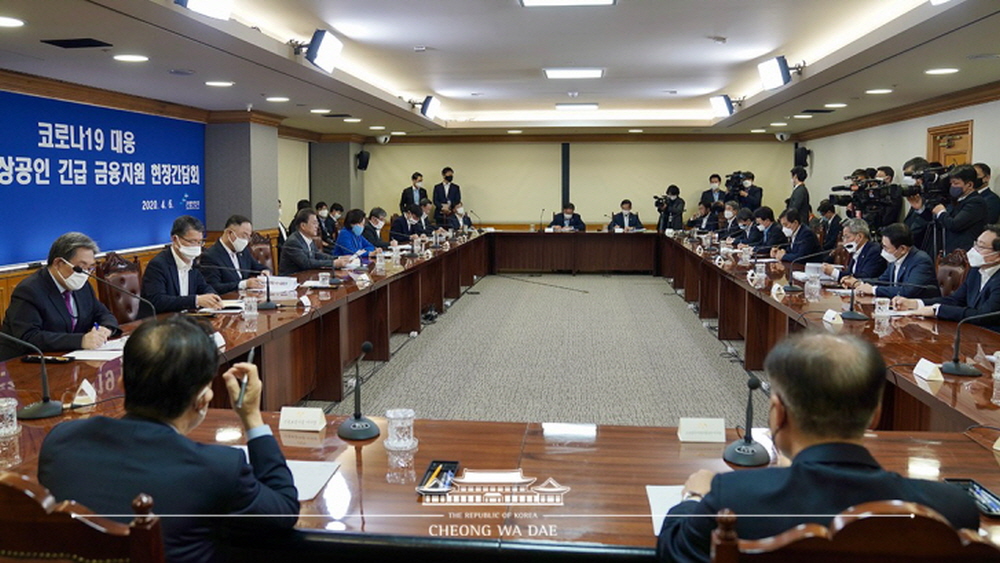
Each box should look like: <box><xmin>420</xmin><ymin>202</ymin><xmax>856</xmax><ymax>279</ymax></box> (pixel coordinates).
<box><xmin>893</xmin><ymin>224</ymin><xmax>1000</xmax><ymax>332</ymax></box>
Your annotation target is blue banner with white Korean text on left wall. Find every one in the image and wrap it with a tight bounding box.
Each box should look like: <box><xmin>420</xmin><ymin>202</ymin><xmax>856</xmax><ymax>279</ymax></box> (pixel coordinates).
<box><xmin>0</xmin><ymin>92</ymin><xmax>205</xmax><ymax>264</ymax></box>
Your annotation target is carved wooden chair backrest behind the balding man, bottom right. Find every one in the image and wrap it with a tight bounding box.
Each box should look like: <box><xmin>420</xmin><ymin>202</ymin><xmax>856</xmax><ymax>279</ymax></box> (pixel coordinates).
<box><xmin>712</xmin><ymin>500</ymin><xmax>1000</xmax><ymax>563</ymax></box>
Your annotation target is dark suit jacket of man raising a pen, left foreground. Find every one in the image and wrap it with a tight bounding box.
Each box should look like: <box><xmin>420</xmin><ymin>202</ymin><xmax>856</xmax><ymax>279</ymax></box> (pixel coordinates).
<box><xmin>38</xmin><ymin>415</ymin><xmax>299</xmax><ymax>563</ymax></box>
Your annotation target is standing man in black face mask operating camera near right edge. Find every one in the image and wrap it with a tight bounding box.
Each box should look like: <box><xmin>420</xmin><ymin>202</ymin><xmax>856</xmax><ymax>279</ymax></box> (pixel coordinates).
<box><xmin>931</xmin><ymin>164</ymin><xmax>987</xmax><ymax>254</ymax></box>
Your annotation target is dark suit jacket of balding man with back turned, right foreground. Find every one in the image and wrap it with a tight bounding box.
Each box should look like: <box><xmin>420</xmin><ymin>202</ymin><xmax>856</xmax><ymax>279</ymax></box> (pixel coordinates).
<box><xmin>656</xmin><ymin>443</ymin><xmax>979</xmax><ymax>562</ymax></box>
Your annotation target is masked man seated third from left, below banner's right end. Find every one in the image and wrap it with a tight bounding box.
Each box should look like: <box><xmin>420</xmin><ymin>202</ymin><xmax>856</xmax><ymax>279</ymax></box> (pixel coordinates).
<box><xmin>198</xmin><ymin>215</ymin><xmax>270</xmax><ymax>295</ymax></box>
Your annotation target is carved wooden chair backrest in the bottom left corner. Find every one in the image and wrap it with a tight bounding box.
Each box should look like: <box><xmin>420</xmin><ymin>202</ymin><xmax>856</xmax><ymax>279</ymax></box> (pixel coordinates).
<box><xmin>0</xmin><ymin>471</ymin><xmax>165</xmax><ymax>563</ymax></box>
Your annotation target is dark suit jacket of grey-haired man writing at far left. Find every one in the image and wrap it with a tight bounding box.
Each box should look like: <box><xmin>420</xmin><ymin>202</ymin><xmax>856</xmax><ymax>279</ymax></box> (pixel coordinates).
<box><xmin>0</xmin><ymin>267</ymin><xmax>118</xmax><ymax>361</ymax></box>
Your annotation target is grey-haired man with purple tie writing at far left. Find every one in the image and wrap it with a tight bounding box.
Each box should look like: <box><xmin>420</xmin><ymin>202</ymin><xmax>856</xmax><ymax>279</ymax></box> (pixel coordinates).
<box><xmin>0</xmin><ymin>233</ymin><xmax>118</xmax><ymax>361</ymax></box>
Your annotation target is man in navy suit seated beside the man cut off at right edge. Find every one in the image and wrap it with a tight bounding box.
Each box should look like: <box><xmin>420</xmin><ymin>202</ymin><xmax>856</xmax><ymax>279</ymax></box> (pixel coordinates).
<box><xmin>840</xmin><ymin>223</ymin><xmax>941</xmax><ymax>298</ymax></box>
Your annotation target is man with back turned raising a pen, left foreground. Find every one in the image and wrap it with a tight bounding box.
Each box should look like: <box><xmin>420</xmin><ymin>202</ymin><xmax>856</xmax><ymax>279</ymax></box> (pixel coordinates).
<box><xmin>38</xmin><ymin>316</ymin><xmax>299</xmax><ymax>562</ymax></box>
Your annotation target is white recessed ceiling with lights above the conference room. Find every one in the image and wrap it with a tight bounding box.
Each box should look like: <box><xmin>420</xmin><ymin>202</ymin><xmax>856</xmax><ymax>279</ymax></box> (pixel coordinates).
<box><xmin>0</xmin><ymin>0</ymin><xmax>1000</xmax><ymax>136</ymax></box>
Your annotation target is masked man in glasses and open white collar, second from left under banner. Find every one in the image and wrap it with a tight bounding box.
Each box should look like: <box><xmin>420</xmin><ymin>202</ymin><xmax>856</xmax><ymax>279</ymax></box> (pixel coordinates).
<box><xmin>139</xmin><ymin>215</ymin><xmax>222</xmax><ymax>318</ymax></box>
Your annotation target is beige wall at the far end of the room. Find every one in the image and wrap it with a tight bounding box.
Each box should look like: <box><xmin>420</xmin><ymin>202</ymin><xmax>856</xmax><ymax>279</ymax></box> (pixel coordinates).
<box><xmin>365</xmin><ymin>141</ymin><xmax>792</xmax><ymax>226</ymax></box>
